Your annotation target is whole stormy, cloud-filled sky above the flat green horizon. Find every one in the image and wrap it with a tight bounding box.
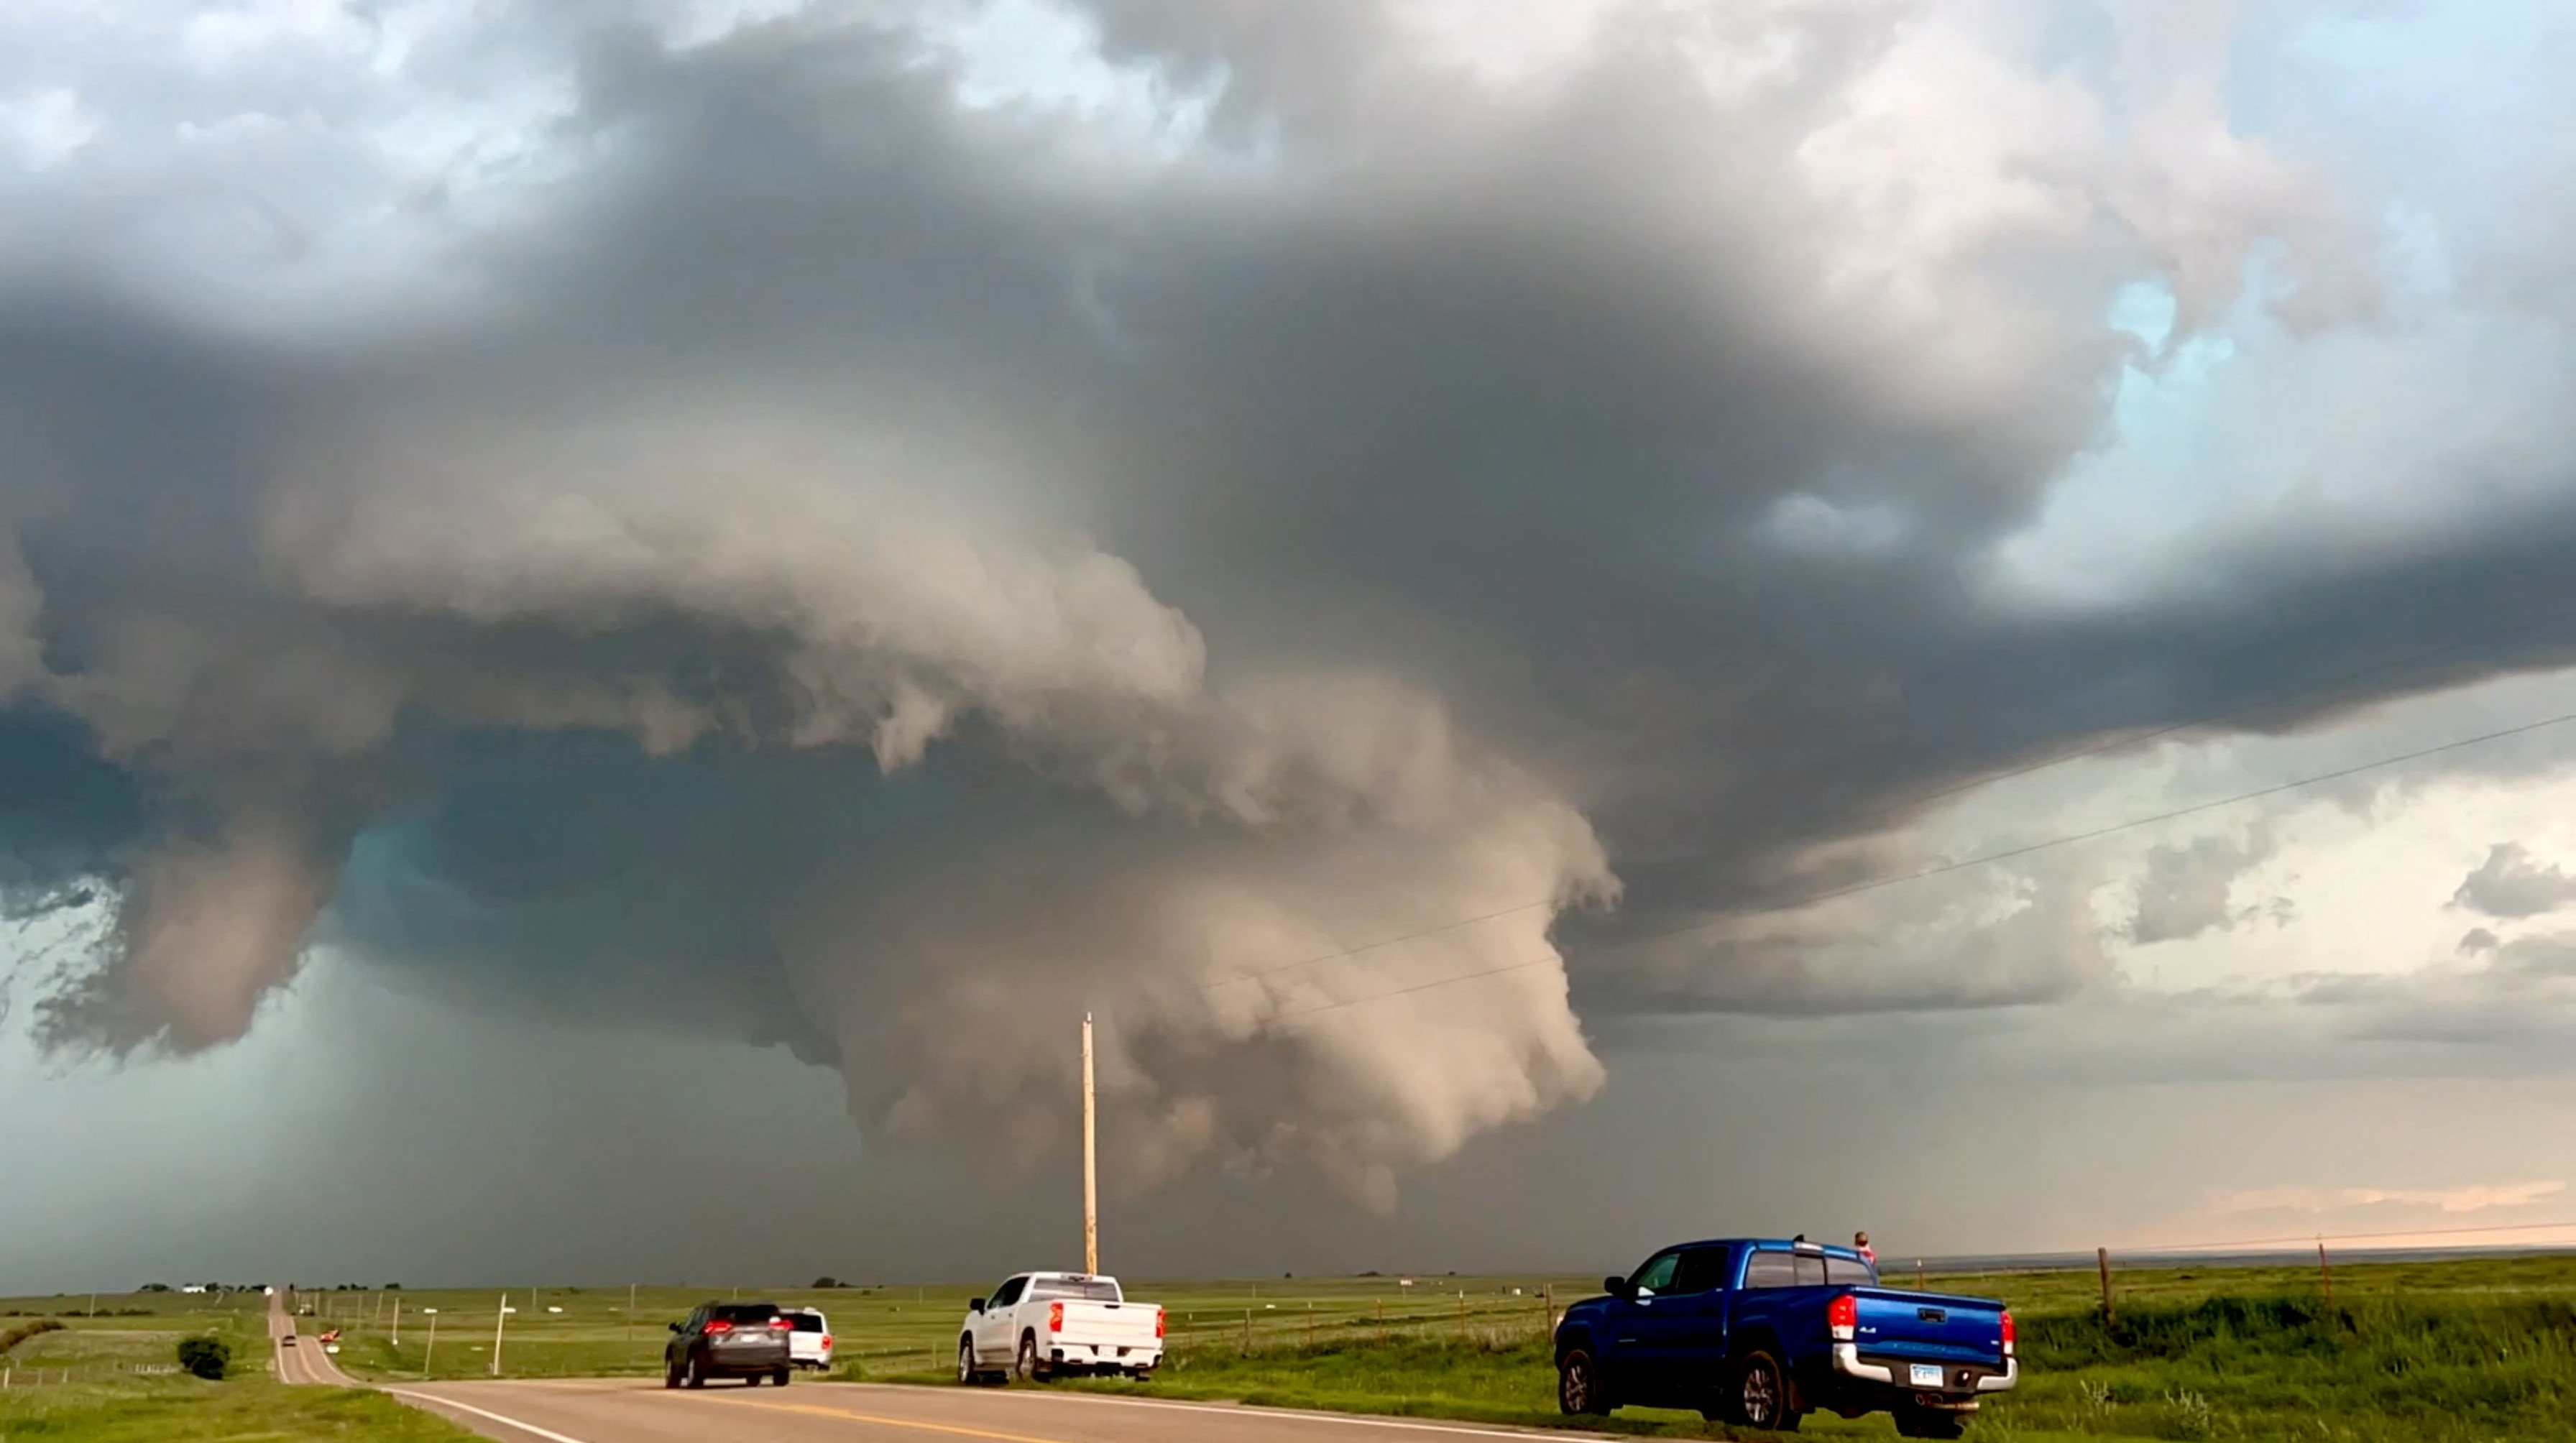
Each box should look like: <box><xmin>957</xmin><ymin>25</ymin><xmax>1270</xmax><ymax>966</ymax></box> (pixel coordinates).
<box><xmin>0</xmin><ymin>0</ymin><xmax>2576</xmax><ymax>1291</ymax></box>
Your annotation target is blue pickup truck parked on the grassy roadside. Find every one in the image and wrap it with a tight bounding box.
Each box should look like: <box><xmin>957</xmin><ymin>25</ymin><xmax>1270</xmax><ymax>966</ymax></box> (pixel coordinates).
<box><xmin>1556</xmin><ymin>1237</ymin><xmax>2020</xmax><ymax>1438</ymax></box>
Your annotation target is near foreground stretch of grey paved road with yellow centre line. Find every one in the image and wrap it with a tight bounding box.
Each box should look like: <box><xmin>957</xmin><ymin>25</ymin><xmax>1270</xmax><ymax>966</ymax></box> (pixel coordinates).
<box><xmin>387</xmin><ymin>1378</ymin><xmax>1584</xmax><ymax>1443</ymax></box>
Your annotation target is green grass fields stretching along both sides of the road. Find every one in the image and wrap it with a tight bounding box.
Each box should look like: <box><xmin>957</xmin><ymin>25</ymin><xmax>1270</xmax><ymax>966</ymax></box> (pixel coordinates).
<box><xmin>0</xmin><ymin>1258</ymin><xmax>2576</xmax><ymax>1443</ymax></box>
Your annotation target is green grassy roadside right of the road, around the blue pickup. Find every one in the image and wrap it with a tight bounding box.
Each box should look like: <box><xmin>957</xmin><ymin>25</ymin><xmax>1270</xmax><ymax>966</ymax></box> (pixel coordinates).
<box><xmin>1009</xmin><ymin>1258</ymin><xmax>2576</xmax><ymax>1443</ymax></box>
